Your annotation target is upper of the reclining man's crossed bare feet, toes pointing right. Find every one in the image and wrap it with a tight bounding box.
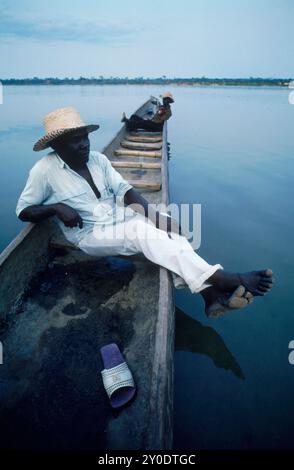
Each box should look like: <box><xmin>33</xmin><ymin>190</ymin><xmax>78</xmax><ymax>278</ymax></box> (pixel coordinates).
<box><xmin>207</xmin><ymin>269</ymin><xmax>273</xmax><ymax>296</ymax></box>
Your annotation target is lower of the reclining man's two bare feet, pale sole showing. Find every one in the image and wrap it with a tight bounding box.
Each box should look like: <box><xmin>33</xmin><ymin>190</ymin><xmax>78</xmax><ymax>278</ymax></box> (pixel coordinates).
<box><xmin>200</xmin><ymin>286</ymin><xmax>253</xmax><ymax>318</ymax></box>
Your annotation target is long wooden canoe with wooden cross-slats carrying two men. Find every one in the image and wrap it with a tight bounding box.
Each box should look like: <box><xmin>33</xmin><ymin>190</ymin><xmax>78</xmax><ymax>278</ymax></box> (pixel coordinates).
<box><xmin>0</xmin><ymin>100</ymin><xmax>174</xmax><ymax>450</ymax></box>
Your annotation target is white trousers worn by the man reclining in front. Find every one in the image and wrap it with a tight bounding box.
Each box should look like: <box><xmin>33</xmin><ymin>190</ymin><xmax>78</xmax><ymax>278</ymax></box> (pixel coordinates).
<box><xmin>79</xmin><ymin>214</ymin><xmax>223</xmax><ymax>293</ymax></box>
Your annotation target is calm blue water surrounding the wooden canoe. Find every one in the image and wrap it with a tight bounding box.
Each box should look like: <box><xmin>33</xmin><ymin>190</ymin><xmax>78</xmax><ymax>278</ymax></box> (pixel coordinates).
<box><xmin>0</xmin><ymin>86</ymin><xmax>294</xmax><ymax>450</ymax></box>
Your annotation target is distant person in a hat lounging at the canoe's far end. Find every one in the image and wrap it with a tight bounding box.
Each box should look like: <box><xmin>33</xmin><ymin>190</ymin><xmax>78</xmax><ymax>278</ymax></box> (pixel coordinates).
<box><xmin>121</xmin><ymin>91</ymin><xmax>174</xmax><ymax>132</ymax></box>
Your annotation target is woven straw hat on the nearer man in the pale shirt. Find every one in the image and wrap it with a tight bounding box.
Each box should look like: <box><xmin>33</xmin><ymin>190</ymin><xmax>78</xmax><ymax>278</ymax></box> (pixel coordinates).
<box><xmin>33</xmin><ymin>106</ymin><xmax>99</xmax><ymax>152</ymax></box>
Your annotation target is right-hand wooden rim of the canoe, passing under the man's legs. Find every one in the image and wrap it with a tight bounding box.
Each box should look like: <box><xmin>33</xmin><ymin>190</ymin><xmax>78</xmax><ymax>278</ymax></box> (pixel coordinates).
<box><xmin>146</xmin><ymin>123</ymin><xmax>175</xmax><ymax>450</ymax></box>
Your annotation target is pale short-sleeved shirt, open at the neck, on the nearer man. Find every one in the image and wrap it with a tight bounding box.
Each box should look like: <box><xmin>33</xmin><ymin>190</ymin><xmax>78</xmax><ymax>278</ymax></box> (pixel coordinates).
<box><xmin>16</xmin><ymin>151</ymin><xmax>135</xmax><ymax>244</ymax></box>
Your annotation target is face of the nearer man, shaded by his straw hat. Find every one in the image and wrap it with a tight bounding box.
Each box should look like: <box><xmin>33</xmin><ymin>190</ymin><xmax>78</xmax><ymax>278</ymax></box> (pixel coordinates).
<box><xmin>51</xmin><ymin>131</ymin><xmax>90</xmax><ymax>166</ymax></box>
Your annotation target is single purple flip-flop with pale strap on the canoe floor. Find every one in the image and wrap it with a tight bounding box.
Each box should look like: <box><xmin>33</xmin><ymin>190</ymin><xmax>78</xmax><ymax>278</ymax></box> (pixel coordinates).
<box><xmin>100</xmin><ymin>343</ymin><xmax>136</xmax><ymax>408</ymax></box>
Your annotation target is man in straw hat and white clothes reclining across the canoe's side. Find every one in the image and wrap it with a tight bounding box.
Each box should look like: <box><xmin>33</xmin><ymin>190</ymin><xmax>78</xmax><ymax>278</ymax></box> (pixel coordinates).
<box><xmin>16</xmin><ymin>107</ymin><xmax>272</xmax><ymax>316</ymax></box>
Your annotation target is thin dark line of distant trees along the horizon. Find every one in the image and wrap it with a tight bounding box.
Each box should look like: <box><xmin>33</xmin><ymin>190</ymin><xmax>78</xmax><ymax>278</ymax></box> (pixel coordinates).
<box><xmin>0</xmin><ymin>75</ymin><xmax>292</xmax><ymax>86</ymax></box>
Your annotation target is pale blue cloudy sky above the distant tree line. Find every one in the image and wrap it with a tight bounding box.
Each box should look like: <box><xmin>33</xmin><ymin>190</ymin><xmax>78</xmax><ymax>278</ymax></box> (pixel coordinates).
<box><xmin>0</xmin><ymin>0</ymin><xmax>294</xmax><ymax>79</ymax></box>
